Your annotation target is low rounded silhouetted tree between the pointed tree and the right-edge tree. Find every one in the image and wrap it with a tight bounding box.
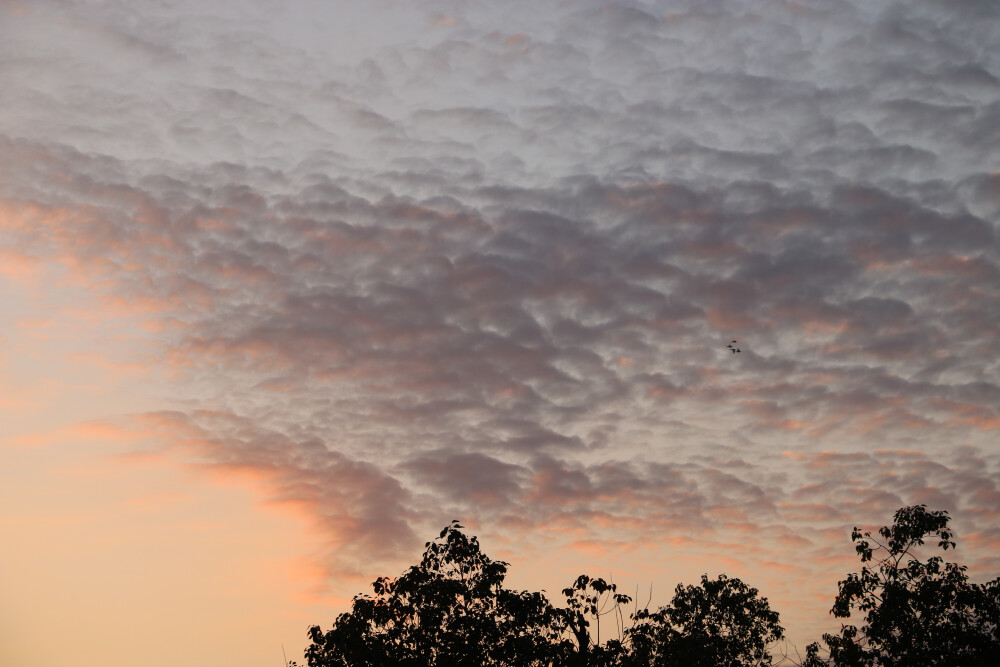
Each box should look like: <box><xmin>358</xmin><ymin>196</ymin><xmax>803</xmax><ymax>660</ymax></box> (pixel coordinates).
<box><xmin>626</xmin><ymin>574</ymin><xmax>784</xmax><ymax>667</ymax></box>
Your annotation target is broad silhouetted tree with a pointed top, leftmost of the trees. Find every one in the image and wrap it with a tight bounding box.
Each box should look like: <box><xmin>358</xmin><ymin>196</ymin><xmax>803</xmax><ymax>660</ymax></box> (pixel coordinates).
<box><xmin>296</xmin><ymin>522</ymin><xmax>567</xmax><ymax>667</ymax></box>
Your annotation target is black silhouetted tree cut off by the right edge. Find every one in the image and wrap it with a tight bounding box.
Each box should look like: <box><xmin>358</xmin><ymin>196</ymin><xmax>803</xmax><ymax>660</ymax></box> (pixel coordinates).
<box><xmin>810</xmin><ymin>505</ymin><xmax>1000</xmax><ymax>667</ymax></box>
